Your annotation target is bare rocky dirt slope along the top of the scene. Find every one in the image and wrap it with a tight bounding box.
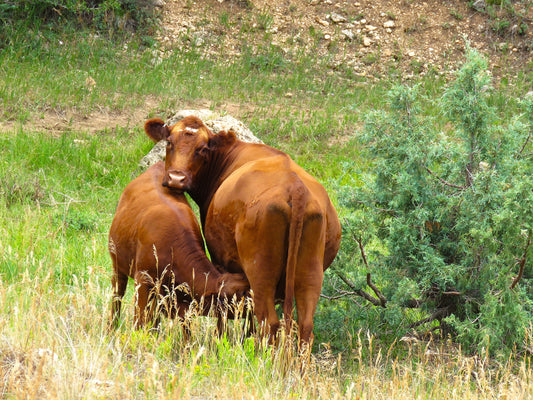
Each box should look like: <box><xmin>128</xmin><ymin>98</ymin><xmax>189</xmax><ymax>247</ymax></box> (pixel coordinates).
<box><xmin>157</xmin><ymin>0</ymin><xmax>533</xmax><ymax>78</ymax></box>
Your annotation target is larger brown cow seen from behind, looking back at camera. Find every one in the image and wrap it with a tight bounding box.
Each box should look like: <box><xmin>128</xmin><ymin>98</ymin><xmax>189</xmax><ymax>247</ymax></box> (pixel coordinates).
<box><xmin>145</xmin><ymin>117</ymin><xmax>341</xmax><ymax>344</ymax></box>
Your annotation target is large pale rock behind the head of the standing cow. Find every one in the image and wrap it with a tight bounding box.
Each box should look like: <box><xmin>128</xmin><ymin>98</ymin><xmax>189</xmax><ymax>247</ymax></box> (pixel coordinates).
<box><xmin>139</xmin><ymin>109</ymin><xmax>263</xmax><ymax>170</ymax></box>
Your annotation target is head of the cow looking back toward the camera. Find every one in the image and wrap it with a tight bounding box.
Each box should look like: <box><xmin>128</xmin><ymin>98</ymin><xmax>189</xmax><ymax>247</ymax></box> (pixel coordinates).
<box><xmin>144</xmin><ymin>116</ymin><xmax>214</xmax><ymax>192</ymax></box>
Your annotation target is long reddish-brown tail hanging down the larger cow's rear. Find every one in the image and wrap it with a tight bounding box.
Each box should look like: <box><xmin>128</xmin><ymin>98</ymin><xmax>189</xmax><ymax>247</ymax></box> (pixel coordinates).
<box><xmin>283</xmin><ymin>178</ymin><xmax>307</xmax><ymax>330</ymax></box>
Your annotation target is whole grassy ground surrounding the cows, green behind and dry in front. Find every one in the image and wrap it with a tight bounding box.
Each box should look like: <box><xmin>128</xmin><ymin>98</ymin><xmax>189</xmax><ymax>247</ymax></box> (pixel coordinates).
<box><xmin>0</xmin><ymin>2</ymin><xmax>533</xmax><ymax>399</ymax></box>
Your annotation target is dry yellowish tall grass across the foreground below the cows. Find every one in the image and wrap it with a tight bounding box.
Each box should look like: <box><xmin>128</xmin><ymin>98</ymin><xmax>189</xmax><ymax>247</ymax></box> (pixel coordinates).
<box><xmin>0</xmin><ymin>267</ymin><xmax>533</xmax><ymax>400</ymax></box>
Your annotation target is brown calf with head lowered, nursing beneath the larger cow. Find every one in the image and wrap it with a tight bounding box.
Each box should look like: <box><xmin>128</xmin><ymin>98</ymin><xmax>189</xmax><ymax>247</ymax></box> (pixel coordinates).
<box><xmin>109</xmin><ymin>162</ymin><xmax>249</xmax><ymax>328</ymax></box>
